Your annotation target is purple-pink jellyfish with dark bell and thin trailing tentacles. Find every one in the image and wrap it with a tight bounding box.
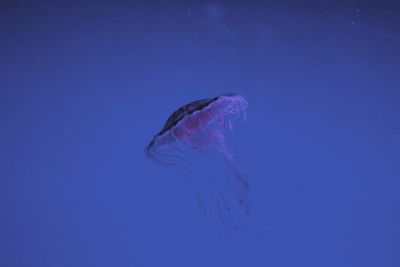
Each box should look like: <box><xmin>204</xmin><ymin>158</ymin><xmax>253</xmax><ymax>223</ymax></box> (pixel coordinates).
<box><xmin>145</xmin><ymin>93</ymin><xmax>250</xmax><ymax>228</ymax></box>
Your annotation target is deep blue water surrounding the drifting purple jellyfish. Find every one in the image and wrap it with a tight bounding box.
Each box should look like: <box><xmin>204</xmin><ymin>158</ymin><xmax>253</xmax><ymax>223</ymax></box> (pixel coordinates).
<box><xmin>0</xmin><ymin>0</ymin><xmax>400</xmax><ymax>267</ymax></box>
